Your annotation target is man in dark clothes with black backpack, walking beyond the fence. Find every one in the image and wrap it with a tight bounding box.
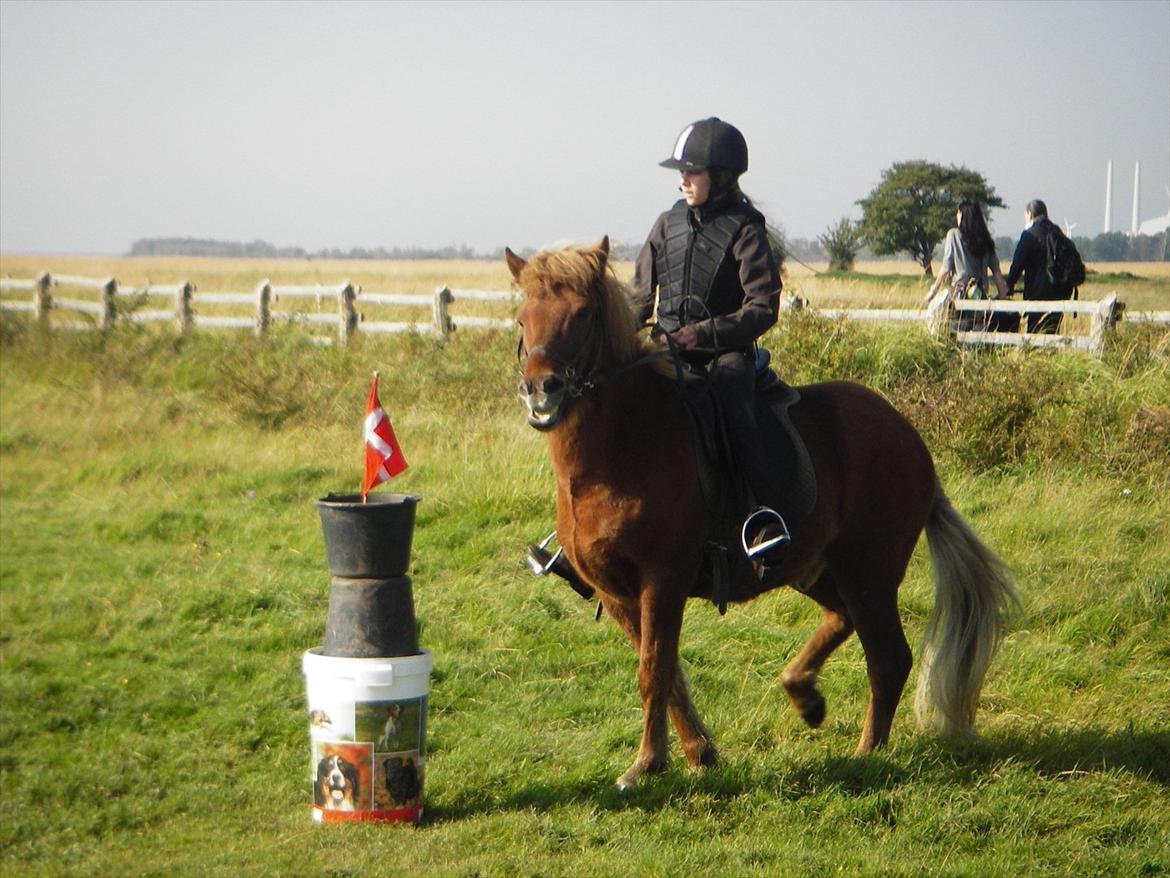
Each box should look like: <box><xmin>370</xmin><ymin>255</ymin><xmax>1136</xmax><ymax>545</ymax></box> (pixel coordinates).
<box><xmin>1007</xmin><ymin>198</ymin><xmax>1085</xmax><ymax>334</ymax></box>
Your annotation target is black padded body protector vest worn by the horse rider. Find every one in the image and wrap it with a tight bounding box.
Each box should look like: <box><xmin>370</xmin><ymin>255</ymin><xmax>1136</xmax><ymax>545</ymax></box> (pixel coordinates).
<box><xmin>654</xmin><ymin>200</ymin><xmax>764</xmax><ymax>332</ymax></box>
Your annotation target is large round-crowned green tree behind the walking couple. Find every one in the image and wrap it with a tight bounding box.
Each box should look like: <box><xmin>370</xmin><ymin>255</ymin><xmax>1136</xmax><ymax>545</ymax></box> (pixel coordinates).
<box><xmin>858</xmin><ymin>160</ymin><xmax>1006</xmax><ymax>276</ymax></box>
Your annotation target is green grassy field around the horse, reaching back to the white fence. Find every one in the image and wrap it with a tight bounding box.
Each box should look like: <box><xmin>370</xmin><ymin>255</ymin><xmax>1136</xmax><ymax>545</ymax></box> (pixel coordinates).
<box><xmin>0</xmin><ymin>316</ymin><xmax>1170</xmax><ymax>876</ymax></box>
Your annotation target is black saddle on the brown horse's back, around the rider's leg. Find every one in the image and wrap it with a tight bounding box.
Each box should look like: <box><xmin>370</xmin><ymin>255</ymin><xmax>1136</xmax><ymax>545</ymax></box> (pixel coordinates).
<box><xmin>683</xmin><ymin>350</ymin><xmax>817</xmax><ymax>613</ymax></box>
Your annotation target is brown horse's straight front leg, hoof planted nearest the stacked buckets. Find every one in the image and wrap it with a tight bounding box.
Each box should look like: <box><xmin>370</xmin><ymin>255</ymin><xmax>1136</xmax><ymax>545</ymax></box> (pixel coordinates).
<box><xmin>618</xmin><ymin>589</ymin><xmax>686</xmax><ymax>789</ymax></box>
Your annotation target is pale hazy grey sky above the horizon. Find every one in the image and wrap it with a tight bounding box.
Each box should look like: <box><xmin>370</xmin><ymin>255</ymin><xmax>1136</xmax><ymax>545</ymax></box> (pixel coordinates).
<box><xmin>0</xmin><ymin>0</ymin><xmax>1170</xmax><ymax>254</ymax></box>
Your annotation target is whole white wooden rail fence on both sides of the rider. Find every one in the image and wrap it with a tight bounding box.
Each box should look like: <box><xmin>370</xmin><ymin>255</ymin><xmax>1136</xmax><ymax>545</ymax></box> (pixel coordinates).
<box><xmin>0</xmin><ymin>273</ymin><xmax>1170</xmax><ymax>351</ymax></box>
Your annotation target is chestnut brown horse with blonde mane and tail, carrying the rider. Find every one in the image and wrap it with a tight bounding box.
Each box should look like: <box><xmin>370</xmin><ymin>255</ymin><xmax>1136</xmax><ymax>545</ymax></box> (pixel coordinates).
<box><xmin>504</xmin><ymin>238</ymin><xmax>1018</xmax><ymax>789</ymax></box>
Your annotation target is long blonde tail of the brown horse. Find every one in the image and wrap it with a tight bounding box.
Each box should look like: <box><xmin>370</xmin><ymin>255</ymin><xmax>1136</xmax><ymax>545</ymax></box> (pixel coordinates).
<box><xmin>914</xmin><ymin>486</ymin><xmax>1019</xmax><ymax>735</ymax></box>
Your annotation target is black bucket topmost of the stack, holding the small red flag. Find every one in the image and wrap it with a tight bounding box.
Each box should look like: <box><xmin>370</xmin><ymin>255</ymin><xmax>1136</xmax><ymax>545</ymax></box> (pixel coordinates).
<box><xmin>317</xmin><ymin>494</ymin><xmax>422</xmax><ymax>579</ymax></box>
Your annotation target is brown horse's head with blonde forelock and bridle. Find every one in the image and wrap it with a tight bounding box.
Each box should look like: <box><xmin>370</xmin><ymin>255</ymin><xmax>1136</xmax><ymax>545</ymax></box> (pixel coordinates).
<box><xmin>504</xmin><ymin>238</ymin><xmax>635</xmax><ymax>430</ymax></box>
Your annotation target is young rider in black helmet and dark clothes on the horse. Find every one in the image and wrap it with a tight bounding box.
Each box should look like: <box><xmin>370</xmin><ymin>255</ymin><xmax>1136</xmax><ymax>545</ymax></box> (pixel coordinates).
<box><xmin>631</xmin><ymin>117</ymin><xmax>789</xmax><ymax>564</ymax></box>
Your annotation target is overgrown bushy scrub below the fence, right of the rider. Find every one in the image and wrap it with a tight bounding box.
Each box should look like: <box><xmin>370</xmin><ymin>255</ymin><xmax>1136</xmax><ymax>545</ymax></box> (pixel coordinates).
<box><xmin>766</xmin><ymin>311</ymin><xmax>1170</xmax><ymax>480</ymax></box>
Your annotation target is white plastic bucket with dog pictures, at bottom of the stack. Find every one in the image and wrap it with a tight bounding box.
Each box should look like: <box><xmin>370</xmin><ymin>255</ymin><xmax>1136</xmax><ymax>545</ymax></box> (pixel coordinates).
<box><xmin>302</xmin><ymin>647</ymin><xmax>431</xmax><ymax>823</ymax></box>
